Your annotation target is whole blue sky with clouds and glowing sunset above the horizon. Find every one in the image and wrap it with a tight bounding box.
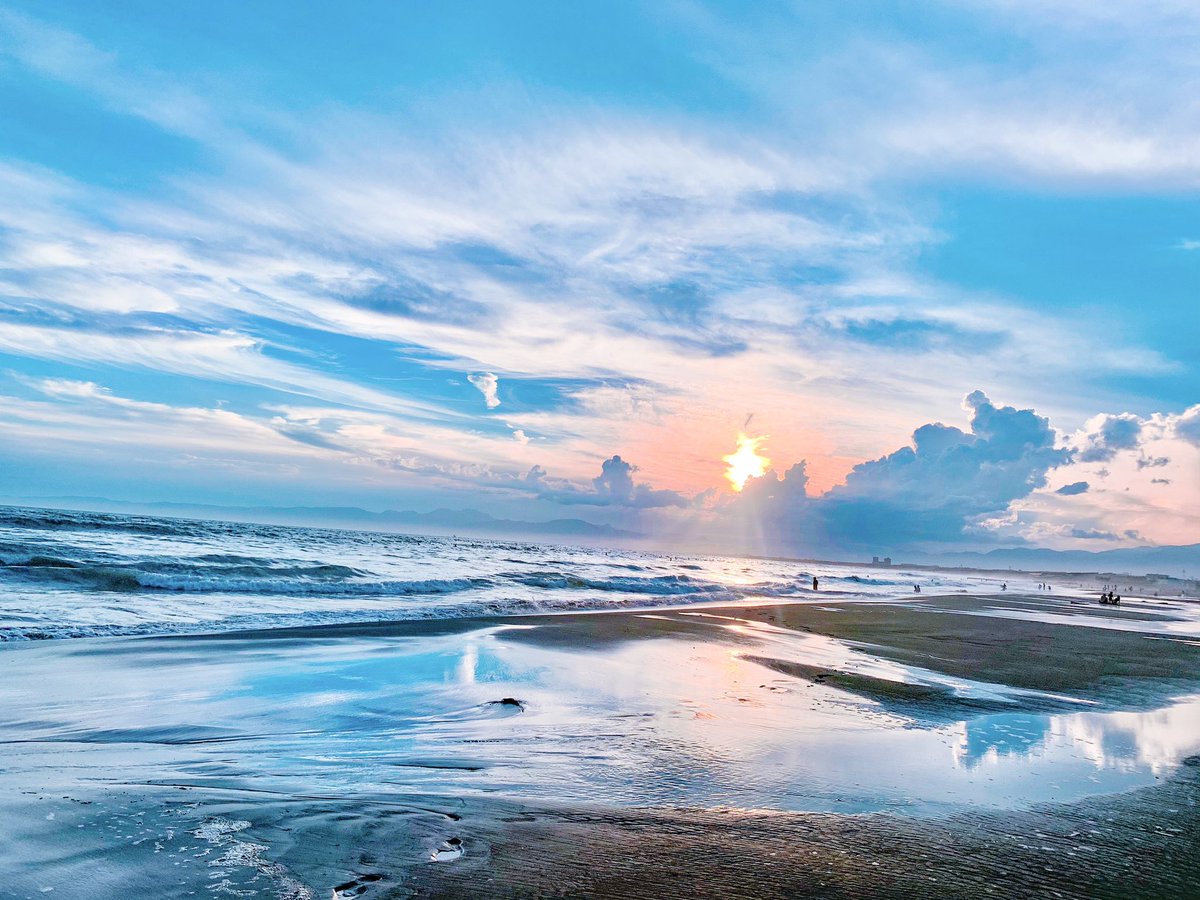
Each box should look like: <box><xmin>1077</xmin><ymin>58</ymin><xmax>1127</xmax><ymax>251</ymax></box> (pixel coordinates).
<box><xmin>0</xmin><ymin>0</ymin><xmax>1200</xmax><ymax>553</ymax></box>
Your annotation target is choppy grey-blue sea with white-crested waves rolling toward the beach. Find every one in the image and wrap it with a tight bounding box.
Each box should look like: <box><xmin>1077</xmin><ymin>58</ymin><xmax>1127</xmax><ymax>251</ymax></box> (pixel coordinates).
<box><xmin>0</xmin><ymin>508</ymin><xmax>1017</xmax><ymax>641</ymax></box>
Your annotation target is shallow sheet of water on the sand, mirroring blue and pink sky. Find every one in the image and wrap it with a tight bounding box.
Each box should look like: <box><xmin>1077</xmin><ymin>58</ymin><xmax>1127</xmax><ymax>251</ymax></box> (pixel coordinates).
<box><xmin>9</xmin><ymin>616</ymin><xmax>1200</xmax><ymax>814</ymax></box>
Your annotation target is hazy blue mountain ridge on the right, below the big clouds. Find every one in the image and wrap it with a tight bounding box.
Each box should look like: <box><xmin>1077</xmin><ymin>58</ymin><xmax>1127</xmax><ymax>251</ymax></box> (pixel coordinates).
<box><xmin>902</xmin><ymin>544</ymin><xmax>1200</xmax><ymax>577</ymax></box>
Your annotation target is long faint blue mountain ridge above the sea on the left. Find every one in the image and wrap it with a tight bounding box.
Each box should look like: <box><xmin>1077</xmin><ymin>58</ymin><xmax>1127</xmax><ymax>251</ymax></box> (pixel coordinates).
<box><xmin>4</xmin><ymin>497</ymin><xmax>642</xmax><ymax>539</ymax></box>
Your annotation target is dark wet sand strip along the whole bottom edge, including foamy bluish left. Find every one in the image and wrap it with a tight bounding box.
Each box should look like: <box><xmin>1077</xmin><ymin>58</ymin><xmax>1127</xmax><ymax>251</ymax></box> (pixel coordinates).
<box><xmin>25</xmin><ymin>757</ymin><xmax>1200</xmax><ymax>900</ymax></box>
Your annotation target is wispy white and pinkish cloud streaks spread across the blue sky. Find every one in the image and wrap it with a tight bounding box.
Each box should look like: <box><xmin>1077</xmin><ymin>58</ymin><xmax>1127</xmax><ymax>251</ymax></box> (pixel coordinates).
<box><xmin>0</xmin><ymin>2</ymin><xmax>1200</xmax><ymax>549</ymax></box>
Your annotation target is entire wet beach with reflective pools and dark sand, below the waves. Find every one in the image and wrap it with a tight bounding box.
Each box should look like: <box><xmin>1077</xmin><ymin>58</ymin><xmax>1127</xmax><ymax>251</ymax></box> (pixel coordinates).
<box><xmin>0</xmin><ymin>593</ymin><xmax>1200</xmax><ymax>898</ymax></box>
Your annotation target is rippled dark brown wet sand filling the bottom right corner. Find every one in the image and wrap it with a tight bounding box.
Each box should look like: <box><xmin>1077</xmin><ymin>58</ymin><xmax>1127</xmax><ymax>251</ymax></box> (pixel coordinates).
<box><xmin>403</xmin><ymin>767</ymin><xmax>1200</xmax><ymax>900</ymax></box>
